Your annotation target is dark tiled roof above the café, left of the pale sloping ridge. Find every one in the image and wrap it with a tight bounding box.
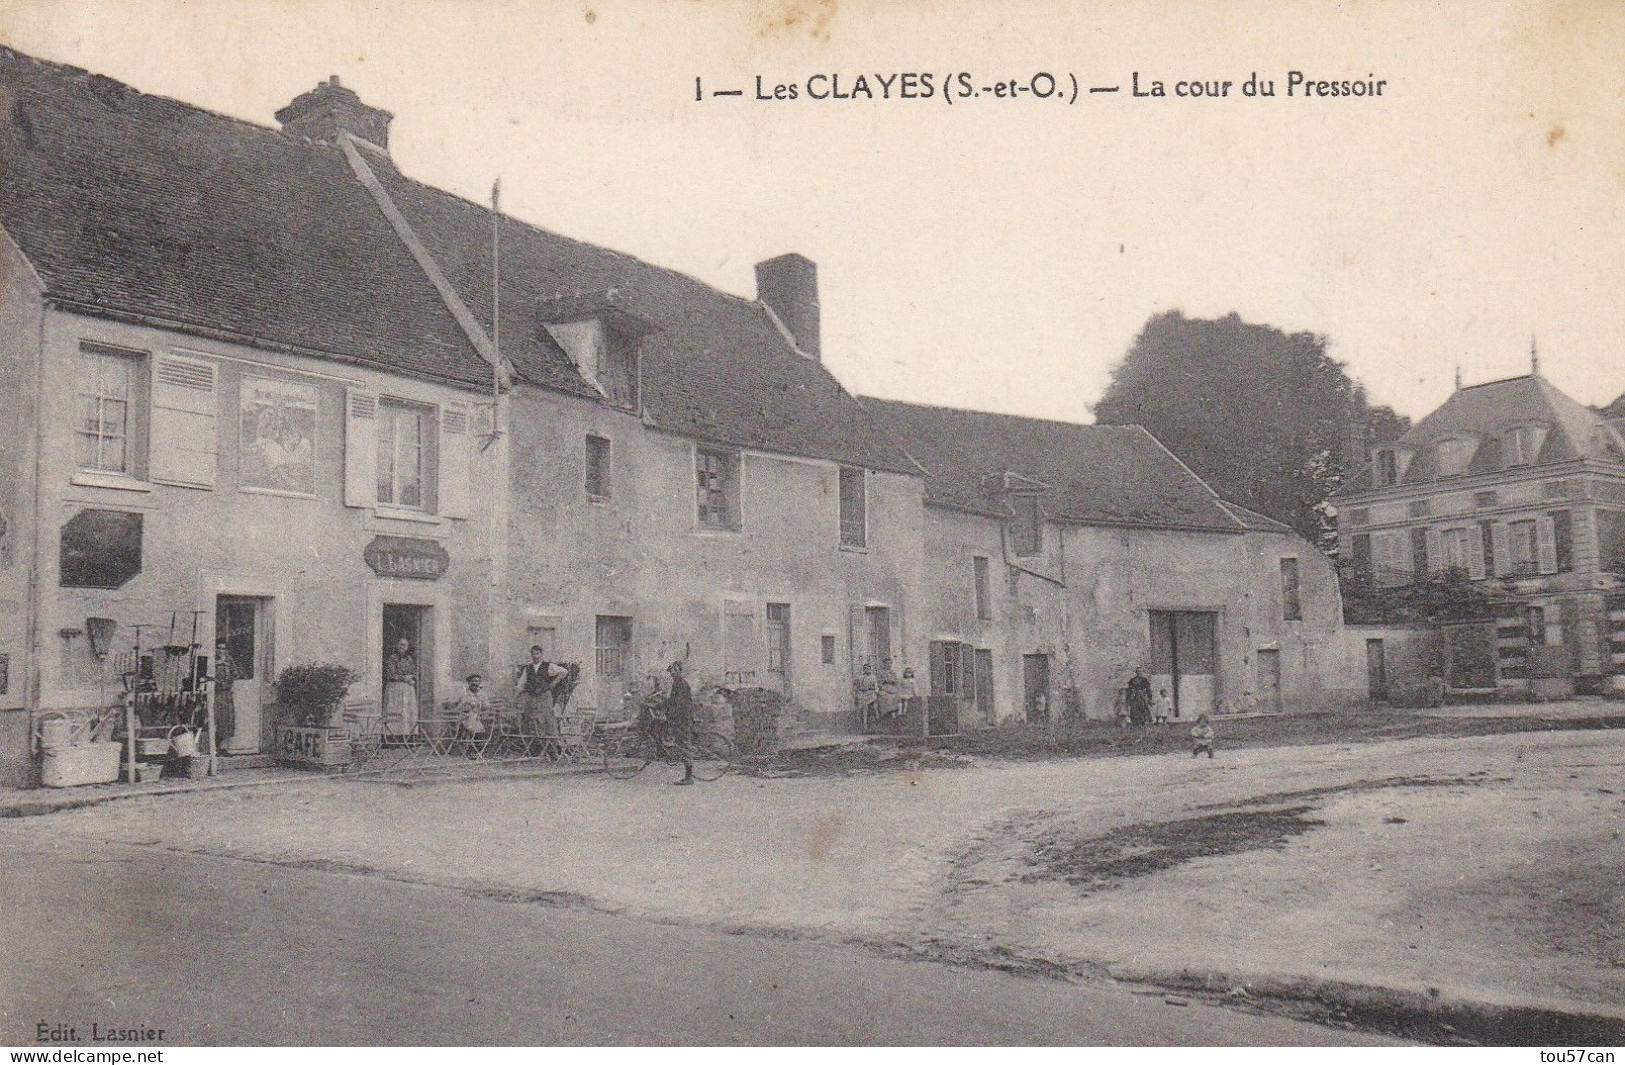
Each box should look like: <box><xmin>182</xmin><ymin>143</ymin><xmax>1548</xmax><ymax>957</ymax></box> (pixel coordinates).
<box><xmin>0</xmin><ymin>49</ymin><xmax>491</xmax><ymax>384</ymax></box>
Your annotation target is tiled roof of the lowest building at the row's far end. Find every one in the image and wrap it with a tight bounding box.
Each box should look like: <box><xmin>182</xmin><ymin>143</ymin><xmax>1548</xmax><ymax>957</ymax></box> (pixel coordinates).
<box><xmin>863</xmin><ymin>398</ymin><xmax>1241</xmax><ymax>533</ymax></box>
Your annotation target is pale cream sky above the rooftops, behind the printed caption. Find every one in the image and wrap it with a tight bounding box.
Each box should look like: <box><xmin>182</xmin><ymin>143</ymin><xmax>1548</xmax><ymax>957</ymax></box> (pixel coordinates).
<box><xmin>0</xmin><ymin>0</ymin><xmax>1625</xmax><ymax>421</ymax></box>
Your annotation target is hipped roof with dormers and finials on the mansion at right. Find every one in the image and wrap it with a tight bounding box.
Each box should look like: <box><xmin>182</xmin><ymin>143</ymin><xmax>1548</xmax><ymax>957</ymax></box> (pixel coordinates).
<box><xmin>1339</xmin><ymin>374</ymin><xmax>1625</xmax><ymax>494</ymax></box>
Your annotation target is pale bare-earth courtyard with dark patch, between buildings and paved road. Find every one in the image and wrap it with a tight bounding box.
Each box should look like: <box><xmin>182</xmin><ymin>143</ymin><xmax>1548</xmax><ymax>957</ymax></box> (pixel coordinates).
<box><xmin>0</xmin><ymin>730</ymin><xmax>1625</xmax><ymax>1042</ymax></box>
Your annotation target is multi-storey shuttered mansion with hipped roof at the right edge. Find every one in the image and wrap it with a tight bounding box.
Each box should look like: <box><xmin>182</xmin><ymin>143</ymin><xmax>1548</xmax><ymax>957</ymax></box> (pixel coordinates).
<box><xmin>1336</xmin><ymin>364</ymin><xmax>1625</xmax><ymax>696</ymax></box>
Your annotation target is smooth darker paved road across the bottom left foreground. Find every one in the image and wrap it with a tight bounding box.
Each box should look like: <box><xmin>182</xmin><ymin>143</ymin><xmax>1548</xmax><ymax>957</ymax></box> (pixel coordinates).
<box><xmin>0</xmin><ymin>829</ymin><xmax>1397</xmax><ymax>1045</ymax></box>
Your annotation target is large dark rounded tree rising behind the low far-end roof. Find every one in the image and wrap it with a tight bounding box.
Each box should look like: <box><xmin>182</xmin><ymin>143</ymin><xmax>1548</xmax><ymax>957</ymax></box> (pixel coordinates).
<box><xmin>1095</xmin><ymin>311</ymin><xmax>1411</xmax><ymax>553</ymax></box>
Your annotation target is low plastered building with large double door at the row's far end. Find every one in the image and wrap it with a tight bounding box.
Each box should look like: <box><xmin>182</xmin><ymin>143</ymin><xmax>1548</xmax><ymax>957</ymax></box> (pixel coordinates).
<box><xmin>865</xmin><ymin>400</ymin><xmax>1365</xmax><ymax>727</ymax></box>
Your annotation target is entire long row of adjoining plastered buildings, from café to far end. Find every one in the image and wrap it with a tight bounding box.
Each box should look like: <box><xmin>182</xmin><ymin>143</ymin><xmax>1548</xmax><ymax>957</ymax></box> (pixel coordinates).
<box><xmin>0</xmin><ymin>49</ymin><xmax>1358</xmax><ymax>784</ymax></box>
